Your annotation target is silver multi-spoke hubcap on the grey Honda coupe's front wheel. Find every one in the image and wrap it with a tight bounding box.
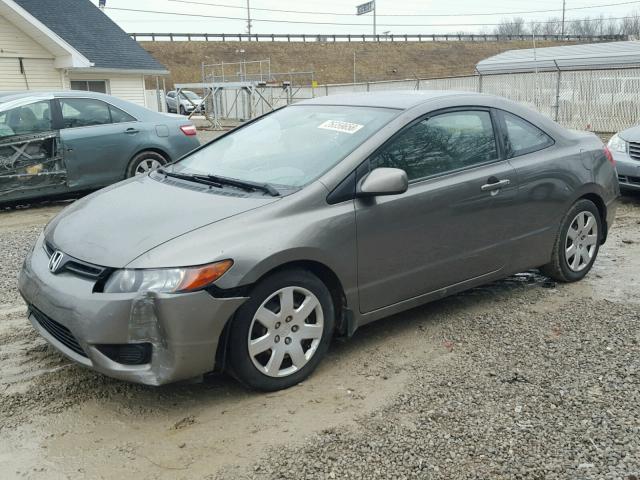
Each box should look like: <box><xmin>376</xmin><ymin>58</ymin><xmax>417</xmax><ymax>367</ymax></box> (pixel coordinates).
<box><xmin>247</xmin><ymin>287</ymin><xmax>324</xmax><ymax>377</ymax></box>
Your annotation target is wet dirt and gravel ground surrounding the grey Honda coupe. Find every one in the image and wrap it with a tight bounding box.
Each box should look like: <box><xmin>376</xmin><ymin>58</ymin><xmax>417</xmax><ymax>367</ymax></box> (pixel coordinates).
<box><xmin>0</xmin><ymin>196</ymin><xmax>640</xmax><ymax>480</ymax></box>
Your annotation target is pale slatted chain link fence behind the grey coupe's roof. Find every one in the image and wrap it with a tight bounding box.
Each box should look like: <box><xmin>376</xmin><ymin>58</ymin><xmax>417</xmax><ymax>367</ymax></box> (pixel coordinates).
<box><xmin>202</xmin><ymin>68</ymin><xmax>640</xmax><ymax>133</ymax></box>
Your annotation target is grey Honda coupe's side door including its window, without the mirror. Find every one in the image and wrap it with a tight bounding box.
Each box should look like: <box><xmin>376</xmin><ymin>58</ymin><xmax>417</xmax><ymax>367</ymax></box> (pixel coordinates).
<box><xmin>355</xmin><ymin>108</ymin><xmax>517</xmax><ymax>313</ymax></box>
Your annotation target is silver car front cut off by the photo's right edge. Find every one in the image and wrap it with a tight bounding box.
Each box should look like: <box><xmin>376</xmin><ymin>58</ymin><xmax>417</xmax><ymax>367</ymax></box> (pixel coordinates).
<box><xmin>608</xmin><ymin>129</ymin><xmax>640</xmax><ymax>191</ymax></box>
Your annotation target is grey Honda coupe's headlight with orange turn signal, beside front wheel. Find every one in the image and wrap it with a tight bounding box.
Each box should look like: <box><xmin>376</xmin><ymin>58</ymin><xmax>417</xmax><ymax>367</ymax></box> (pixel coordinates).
<box><xmin>103</xmin><ymin>260</ymin><xmax>233</xmax><ymax>293</ymax></box>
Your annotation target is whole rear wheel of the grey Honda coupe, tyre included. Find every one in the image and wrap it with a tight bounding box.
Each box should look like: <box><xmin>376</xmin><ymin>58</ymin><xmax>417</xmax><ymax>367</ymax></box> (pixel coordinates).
<box><xmin>541</xmin><ymin>199</ymin><xmax>603</xmax><ymax>282</ymax></box>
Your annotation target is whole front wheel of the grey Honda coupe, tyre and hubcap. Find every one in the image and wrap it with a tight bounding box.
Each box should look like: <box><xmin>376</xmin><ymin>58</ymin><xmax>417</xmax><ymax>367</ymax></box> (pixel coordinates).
<box><xmin>228</xmin><ymin>269</ymin><xmax>335</xmax><ymax>391</ymax></box>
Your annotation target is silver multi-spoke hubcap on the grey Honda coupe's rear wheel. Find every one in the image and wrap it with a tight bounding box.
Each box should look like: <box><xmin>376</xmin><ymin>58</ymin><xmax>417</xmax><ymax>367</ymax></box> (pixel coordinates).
<box><xmin>564</xmin><ymin>211</ymin><xmax>598</xmax><ymax>272</ymax></box>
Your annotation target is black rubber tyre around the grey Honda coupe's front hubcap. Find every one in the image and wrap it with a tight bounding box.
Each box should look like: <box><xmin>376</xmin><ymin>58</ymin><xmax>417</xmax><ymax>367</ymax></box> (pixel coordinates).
<box><xmin>227</xmin><ymin>269</ymin><xmax>335</xmax><ymax>391</ymax></box>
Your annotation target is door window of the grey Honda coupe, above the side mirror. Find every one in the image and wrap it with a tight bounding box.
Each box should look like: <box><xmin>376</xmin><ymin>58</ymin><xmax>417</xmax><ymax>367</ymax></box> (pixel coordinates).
<box><xmin>371</xmin><ymin>110</ymin><xmax>498</xmax><ymax>181</ymax></box>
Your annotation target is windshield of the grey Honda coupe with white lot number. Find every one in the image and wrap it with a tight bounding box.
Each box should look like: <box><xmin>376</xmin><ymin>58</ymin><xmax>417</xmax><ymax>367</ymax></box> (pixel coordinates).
<box><xmin>173</xmin><ymin>105</ymin><xmax>398</xmax><ymax>187</ymax></box>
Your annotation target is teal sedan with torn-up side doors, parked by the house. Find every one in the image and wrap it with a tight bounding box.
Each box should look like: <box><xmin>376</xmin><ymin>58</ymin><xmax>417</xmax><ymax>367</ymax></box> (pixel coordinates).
<box><xmin>0</xmin><ymin>91</ymin><xmax>199</xmax><ymax>204</ymax></box>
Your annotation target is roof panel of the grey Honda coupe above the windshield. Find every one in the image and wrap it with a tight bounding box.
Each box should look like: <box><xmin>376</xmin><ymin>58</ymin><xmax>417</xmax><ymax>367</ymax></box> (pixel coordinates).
<box><xmin>296</xmin><ymin>90</ymin><xmax>493</xmax><ymax>110</ymax></box>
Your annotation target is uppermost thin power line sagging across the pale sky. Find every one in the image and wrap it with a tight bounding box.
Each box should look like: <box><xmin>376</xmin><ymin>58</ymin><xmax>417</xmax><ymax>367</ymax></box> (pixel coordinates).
<box><xmin>169</xmin><ymin>0</ymin><xmax>640</xmax><ymax>17</ymax></box>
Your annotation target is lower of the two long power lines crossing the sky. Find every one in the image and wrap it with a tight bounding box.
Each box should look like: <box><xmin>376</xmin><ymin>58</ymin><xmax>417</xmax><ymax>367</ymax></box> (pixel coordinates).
<box><xmin>107</xmin><ymin>7</ymin><xmax>635</xmax><ymax>27</ymax></box>
